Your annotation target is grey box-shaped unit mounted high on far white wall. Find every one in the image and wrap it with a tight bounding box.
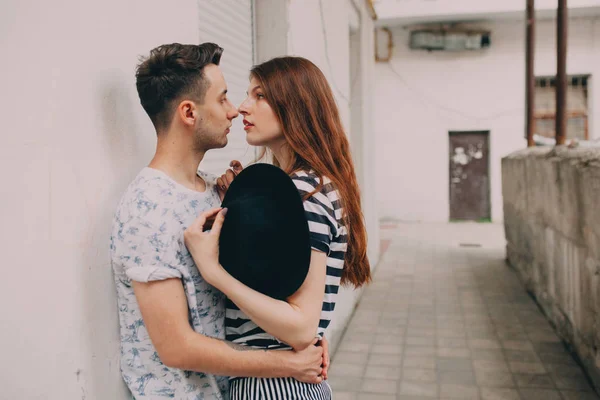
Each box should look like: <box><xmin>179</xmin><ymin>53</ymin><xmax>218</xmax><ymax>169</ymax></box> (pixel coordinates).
<box><xmin>410</xmin><ymin>30</ymin><xmax>491</xmax><ymax>51</ymax></box>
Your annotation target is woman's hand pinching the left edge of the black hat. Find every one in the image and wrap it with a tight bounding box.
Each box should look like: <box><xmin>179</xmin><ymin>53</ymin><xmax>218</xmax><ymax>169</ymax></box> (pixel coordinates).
<box><xmin>183</xmin><ymin>208</ymin><xmax>227</xmax><ymax>286</ymax></box>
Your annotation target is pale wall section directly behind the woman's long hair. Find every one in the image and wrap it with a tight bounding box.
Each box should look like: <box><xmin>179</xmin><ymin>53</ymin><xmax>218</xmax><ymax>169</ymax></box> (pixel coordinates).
<box><xmin>256</xmin><ymin>0</ymin><xmax>379</xmax><ymax>348</ymax></box>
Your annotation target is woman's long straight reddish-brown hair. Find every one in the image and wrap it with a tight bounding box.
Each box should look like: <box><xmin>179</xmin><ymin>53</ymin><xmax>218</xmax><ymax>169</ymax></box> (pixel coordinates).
<box><xmin>250</xmin><ymin>57</ymin><xmax>371</xmax><ymax>287</ymax></box>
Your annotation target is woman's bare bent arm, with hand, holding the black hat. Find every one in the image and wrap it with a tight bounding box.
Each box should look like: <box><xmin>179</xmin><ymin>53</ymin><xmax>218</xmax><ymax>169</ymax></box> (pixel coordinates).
<box><xmin>184</xmin><ymin>209</ymin><xmax>327</xmax><ymax>350</ymax></box>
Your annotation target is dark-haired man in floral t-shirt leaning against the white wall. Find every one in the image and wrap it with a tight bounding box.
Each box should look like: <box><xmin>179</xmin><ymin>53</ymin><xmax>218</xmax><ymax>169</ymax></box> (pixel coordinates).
<box><xmin>110</xmin><ymin>43</ymin><xmax>323</xmax><ymax>400</ymax></box>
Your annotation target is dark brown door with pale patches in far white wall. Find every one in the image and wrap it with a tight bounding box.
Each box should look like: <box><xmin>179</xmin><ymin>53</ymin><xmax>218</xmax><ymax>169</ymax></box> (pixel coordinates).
<box><xmin>450</xmin><ymin>131</ymin><xmax>491</xmax><ymax>221</ymax></box>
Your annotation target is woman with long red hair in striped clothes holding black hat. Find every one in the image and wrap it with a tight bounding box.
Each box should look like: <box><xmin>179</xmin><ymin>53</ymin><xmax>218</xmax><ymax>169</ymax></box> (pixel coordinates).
<box><xmin>186</xmin><ymin>57</ymin><xmax>371</xmax><ymax>399</ymax></box>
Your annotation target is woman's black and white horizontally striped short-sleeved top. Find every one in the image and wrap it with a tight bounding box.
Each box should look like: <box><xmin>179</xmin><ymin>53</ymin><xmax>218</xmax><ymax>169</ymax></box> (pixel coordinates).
<box><xmin>225</xmin><ymin>171</ymin><xmax>347</xmax><ymax>349</ymax></box>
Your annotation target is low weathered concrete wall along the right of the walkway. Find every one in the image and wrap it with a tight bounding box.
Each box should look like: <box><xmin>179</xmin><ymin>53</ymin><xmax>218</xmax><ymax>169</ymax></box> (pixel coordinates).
<box><xmin>502</xmin><ymin>148</ymin><xmax>600</xmax><ymax>388</ymax></box>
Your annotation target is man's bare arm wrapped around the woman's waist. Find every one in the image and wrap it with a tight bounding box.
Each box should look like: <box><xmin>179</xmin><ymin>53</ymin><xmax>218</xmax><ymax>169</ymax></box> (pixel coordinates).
<box><xmin>133</xmin><ymin>279</ymin><xmax>323</xmax><ymax>383</ymax></box>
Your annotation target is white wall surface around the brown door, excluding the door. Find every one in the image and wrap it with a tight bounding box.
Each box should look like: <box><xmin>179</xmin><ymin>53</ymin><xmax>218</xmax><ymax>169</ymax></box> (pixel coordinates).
<box><xmin>373</xmin><ymin>19</ymin><xmax>600</xmax><ymax>221</ymax></box>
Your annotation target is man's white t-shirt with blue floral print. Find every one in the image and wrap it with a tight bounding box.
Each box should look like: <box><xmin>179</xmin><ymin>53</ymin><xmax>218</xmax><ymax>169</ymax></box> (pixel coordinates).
<box><xmin>110</xmin><ymin>168</ymin><xmax>228</xmax><ymax>400</ymax></box>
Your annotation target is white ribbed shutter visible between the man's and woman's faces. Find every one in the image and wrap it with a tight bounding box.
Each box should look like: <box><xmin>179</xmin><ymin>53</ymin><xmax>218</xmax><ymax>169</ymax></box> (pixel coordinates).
<box><xmin>198</xmin><ymin>0</ymin><xmax>257</xmax><ymax>175</ymax></box>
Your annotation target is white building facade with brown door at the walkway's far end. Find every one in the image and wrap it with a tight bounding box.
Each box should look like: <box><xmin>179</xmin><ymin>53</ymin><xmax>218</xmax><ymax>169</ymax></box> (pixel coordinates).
<box><xmin>374</xmin><ymin>0</ymin><xmax>600</xmax><ymax>222</ymax></box>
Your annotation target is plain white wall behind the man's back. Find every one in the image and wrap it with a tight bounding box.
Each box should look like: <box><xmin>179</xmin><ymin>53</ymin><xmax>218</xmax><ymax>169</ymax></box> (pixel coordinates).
<box><xmin>0</xmin><ymin>0</ymin><xmax>198</xmax><ymax>400</ymax></box>
